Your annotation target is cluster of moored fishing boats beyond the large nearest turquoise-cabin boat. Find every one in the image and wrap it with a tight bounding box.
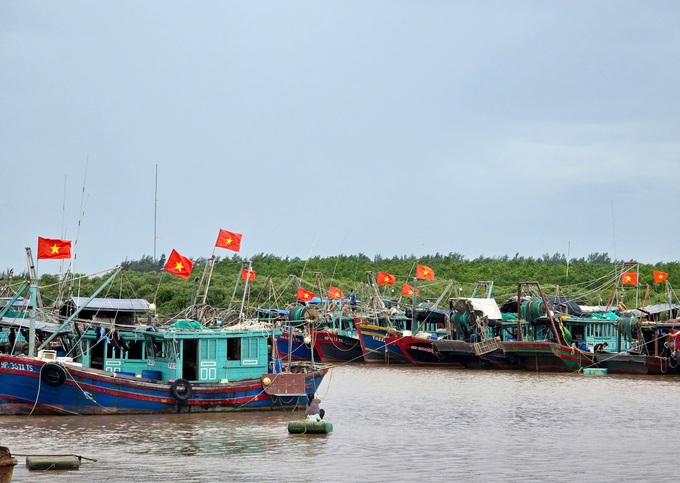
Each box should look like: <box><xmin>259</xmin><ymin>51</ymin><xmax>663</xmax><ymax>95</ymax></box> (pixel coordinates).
<box><xmin>276</xmin><ymin>282</ymin><xmax>680</xmax><ymax>374</ymax></box>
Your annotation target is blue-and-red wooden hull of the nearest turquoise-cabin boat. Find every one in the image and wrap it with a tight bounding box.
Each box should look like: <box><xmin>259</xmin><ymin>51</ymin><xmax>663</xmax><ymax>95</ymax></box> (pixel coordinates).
<box><xmin>0</xmin><ymin>355</ymin><xmax>328</xmax><ymax>415</ymax></box>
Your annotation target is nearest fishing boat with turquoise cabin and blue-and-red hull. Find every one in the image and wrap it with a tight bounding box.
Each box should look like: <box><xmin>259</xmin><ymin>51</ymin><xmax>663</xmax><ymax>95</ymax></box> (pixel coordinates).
<box><xmin>0</xmin><ymin>269</ymin><xmax>327</xmax><ymax>415</ymax></box>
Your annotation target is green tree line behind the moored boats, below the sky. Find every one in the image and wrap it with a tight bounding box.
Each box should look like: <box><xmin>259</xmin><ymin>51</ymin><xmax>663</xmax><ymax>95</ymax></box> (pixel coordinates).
<box><xmin>5</xmin><ymin>252</ymin><xmax>680</xmax><ymax>314</ymax></box>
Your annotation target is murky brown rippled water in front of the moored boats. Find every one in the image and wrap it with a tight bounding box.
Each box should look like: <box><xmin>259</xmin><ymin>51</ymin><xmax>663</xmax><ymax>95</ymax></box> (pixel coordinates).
<box><xmin>0</xmin><ymin>365</ymin><xmax>680</xmax><ymax>483</ymax></box>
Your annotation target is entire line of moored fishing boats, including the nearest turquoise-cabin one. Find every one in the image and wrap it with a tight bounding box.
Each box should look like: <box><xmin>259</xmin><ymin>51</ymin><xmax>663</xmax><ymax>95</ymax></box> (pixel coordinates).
<box><xmin>0</xmin><ymin>253</ymin><xmax>680</xmax><ymax>415</ymax></box>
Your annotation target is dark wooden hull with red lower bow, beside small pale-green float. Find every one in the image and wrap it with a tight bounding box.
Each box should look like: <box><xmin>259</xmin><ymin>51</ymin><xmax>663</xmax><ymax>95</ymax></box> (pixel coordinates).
<box><xmin>502</xmin><ymin>341</ymin><xmax>594</xmax><ymax>372</ymax></box>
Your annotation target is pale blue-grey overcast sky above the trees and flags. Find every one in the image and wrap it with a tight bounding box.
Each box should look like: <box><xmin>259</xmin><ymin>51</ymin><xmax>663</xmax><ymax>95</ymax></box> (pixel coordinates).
<box><xmin>0</xmin><ymin>0</ymin><xmax>680</xmax><ymax>273</ymax></box>
